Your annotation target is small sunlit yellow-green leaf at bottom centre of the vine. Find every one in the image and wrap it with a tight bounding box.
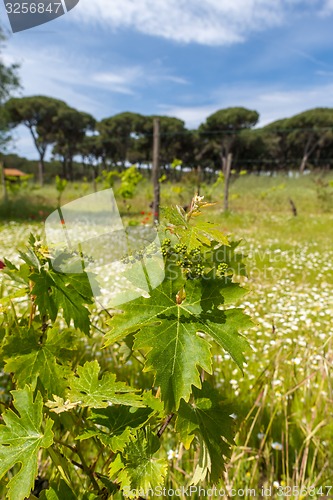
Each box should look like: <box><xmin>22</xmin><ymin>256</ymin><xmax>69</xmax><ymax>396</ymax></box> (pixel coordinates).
<box><xmin>110</xmin><ymin>428</ymin><xmax>168</xmax><ymax>496</ymax></box>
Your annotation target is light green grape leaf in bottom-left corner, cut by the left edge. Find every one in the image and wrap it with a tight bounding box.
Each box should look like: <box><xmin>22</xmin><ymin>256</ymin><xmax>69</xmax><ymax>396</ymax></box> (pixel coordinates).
<box><xmin>0</xmin><ymin>386</ymin><xmax>53</xmax><ymax>500</ymax></box>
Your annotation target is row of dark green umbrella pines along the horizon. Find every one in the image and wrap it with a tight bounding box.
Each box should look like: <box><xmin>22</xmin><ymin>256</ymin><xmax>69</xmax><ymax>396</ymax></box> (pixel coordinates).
<box><xmin>0</xmin><ymin>96</ymin><xmax>333</xmax><ymax>182</ymax></box>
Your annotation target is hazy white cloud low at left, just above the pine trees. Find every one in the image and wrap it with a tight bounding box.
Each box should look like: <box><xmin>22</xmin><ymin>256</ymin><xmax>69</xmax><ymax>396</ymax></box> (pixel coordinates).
<box><xmin>4</xmin><ymin>44</ymin><xmax>187</xmax><ymax>116</ymax></box>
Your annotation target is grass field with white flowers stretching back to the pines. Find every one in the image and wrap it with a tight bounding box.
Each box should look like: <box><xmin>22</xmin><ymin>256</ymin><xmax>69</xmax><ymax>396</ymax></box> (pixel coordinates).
<box><xmin>0</xmin><ymin>172</ymin><xmax>333</xmax><ymax>498</ymax></box>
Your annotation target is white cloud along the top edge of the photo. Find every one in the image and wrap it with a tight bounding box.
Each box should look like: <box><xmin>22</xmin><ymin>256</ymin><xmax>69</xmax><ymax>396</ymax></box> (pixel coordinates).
<box><xmin>71</xmin><ymin>0</ymin><xmax>326</xmax><ymax>45</ymax></box>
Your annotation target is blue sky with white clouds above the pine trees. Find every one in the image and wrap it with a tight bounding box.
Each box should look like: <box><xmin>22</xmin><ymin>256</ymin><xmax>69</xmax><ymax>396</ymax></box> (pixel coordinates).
<box><xmin>0</xmin><ymin>0</ymin><xmax>333</xmax><ymax>158</ymax></box>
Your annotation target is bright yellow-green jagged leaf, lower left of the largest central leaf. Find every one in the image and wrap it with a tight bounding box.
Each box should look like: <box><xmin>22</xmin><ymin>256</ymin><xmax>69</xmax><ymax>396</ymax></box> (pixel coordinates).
<box><xmin>68</xmin><ymin>361</ymin><xmax>144</xmax><ymax>408</ymax></box>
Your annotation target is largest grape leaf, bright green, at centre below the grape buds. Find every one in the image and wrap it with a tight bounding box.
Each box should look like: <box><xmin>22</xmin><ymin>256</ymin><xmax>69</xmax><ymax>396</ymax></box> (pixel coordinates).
<box><xmin>106</xmin><ymin>279</ymin><xmax>251</xmax><ymax>411</ymax></box>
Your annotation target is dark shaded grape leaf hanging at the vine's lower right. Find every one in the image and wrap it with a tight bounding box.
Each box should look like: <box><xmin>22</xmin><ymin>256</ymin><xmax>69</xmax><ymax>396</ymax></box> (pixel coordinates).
<box><xmin>176</xmin><ymin>382</ymin><xmax>234</xmax><ymax>484</ymax></box>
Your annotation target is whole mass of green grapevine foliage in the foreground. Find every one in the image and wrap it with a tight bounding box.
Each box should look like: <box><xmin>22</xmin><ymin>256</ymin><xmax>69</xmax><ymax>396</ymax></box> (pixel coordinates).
<box><xmin>0</xmin><ymin>197</ymin><xmax>251</xmax><ymax>500</ymax></box>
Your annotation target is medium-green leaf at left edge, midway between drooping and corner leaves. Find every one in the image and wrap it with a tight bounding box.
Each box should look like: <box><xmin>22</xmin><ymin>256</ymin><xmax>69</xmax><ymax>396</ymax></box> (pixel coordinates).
<box><xmin>3</xmin><ymin>328</ymin><xmax>75</xmax><ymax>396</ymax></box>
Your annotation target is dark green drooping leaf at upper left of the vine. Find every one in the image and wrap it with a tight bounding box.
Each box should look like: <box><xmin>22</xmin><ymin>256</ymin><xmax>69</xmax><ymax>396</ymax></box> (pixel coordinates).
<box><xmin>30</xmin><ymin>269</ymin><xmax>92</xmax><ymax>334</ymax></box>
